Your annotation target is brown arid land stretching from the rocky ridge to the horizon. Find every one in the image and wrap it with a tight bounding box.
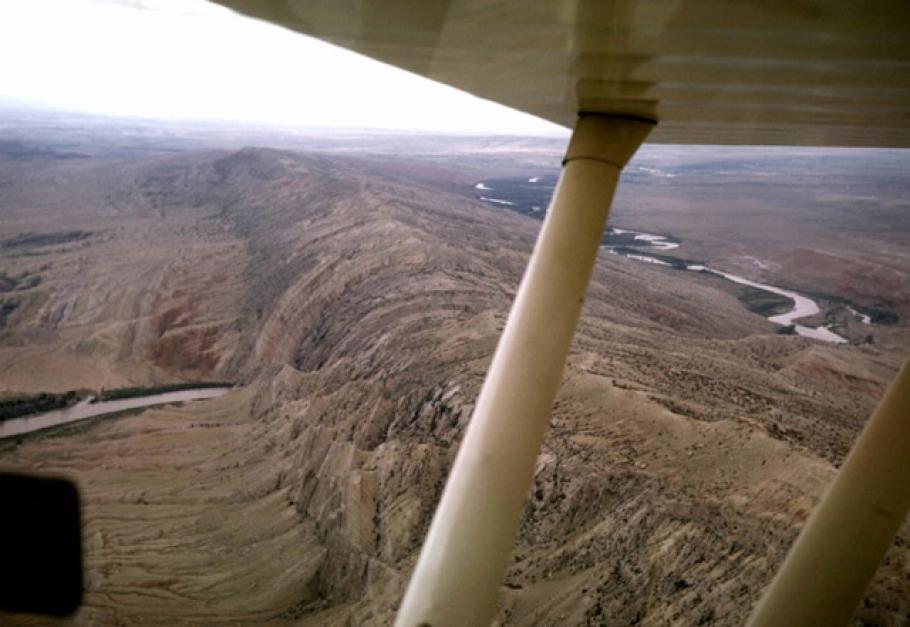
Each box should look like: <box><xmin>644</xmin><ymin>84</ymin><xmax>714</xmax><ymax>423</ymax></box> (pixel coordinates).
<box><xmin>0</xmin><ymin>118</ymin><xmax>910</xmax><ymax>626</ymax></box>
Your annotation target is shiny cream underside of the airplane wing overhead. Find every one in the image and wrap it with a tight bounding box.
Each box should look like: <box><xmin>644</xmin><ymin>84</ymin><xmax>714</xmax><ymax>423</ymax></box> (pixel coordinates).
<box><xmin>217</xmin><ymin>0</ymin><xmax>910</xmax><ymax>147</ymax></box>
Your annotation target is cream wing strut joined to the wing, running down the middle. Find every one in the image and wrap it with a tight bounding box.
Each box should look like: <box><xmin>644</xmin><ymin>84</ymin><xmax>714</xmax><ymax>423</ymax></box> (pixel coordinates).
<box><xmin>395</xmin><ymin>114</ymin><xmax>654</xmax><ymax>627</ymax></box>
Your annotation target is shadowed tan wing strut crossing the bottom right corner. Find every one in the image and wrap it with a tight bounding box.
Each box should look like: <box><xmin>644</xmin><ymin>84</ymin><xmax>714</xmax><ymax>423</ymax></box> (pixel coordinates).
<box><xmin>748</xmin><ymin>361</ymin><xmax>910</xmax><ymax>627</ymax></box>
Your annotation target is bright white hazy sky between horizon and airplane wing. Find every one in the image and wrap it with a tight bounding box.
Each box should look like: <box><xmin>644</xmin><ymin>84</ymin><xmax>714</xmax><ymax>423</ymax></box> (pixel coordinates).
<box><xmin>0</xmin><ymin>0</ymin><xmax>561</xmax><ymax>134</ymax></box>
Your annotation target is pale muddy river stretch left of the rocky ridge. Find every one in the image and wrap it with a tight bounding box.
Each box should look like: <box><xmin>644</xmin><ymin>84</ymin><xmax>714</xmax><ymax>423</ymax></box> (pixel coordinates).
<box><xmin>0</xmin><ymin>387</ymin><xmax>231</xmax><ymax>438</ymax></box>
